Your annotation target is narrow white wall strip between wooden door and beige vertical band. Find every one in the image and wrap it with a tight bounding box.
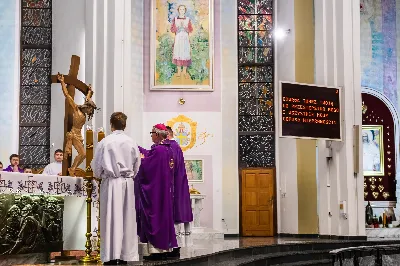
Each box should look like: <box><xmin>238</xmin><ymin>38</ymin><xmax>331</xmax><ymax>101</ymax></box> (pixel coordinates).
<box><xmin>275</xmin><ymin>0</ymin><xmax>298</xmax><ymax>234</ymax></box>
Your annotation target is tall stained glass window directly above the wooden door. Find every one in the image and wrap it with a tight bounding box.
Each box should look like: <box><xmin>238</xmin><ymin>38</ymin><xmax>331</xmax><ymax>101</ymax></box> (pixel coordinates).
<box><xmin>238</xmin><ymin>0</ymin><xmax>275</xmax><ymax>167</ymax></box>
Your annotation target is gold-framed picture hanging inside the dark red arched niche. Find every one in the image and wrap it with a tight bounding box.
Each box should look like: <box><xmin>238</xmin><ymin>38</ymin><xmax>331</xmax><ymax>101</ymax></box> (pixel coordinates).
<box><xmin>362</xmin><ymin>125</ymin><xmax>385</xmax><ymax>176</ymax></box>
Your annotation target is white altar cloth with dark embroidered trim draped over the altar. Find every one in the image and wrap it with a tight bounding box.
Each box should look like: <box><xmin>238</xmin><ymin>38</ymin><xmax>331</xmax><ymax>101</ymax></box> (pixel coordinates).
<box><xmin>0</xmin><ymin>172</ymin><xmax>99</xmax><ymax>250</ymax></box>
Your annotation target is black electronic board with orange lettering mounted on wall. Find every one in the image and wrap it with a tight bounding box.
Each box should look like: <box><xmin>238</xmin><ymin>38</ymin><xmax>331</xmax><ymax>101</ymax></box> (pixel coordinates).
<box><xmin>280</xmin><ymin>82</ymin><xmax>341</xmax><ymax>140</ymax></box>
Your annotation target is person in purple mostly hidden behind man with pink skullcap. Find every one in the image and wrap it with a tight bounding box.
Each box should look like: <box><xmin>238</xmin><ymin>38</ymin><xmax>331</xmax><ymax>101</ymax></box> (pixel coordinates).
<box><xmin>167</xmin><ymin>126</ymin><xmax>193</xmax><ymax>257</ymax></box>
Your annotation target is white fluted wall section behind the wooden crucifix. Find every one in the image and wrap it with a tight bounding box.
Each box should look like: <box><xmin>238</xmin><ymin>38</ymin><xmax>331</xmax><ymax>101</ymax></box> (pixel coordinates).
<box><xmin>50</xmin><ymin>0</ymin><xmax>139</xmax><ymax>149</ymax></box>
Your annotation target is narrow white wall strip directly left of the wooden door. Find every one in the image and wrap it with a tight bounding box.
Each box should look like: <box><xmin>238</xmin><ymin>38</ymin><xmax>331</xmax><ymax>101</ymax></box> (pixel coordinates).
<box><xmin>220</xmin><ymin>0</ymin><xmax>239</xmax><ymax>234</ymax></box>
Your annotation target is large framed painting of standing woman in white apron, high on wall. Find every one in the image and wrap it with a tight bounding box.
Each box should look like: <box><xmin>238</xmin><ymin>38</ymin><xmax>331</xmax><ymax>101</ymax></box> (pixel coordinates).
<box><xmin>150</xmin><ymin>0</ymin><xmax>214</xmax><ymax>91</ymax></box>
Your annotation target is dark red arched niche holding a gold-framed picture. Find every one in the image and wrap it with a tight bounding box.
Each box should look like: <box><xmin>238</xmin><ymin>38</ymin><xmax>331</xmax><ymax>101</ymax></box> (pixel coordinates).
<box><xmin>362</xmin><ymin>88</ymin><xmax>399</xmax><ymax>211</ymax></box>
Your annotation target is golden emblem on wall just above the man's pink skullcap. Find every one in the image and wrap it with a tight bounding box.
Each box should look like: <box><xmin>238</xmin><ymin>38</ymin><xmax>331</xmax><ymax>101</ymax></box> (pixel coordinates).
<box><xmin>166</xmin><ymin>115</ymin><xmax>197</xmax><ymax>151</ymax></box>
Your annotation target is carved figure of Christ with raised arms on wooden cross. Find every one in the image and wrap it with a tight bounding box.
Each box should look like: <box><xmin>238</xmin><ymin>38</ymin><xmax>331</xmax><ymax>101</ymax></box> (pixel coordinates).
<box><xmin>57</xmin><ymin>73</ymin><xmax>97</xmax><ymax>176</ymax></box>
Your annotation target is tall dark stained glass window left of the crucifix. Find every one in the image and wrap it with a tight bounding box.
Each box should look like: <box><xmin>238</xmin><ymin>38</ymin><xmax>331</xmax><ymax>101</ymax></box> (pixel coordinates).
<box><xmin>19</xmin><ymin>0</ymin><xmax>52</xmax><ymax>169</ymax></box>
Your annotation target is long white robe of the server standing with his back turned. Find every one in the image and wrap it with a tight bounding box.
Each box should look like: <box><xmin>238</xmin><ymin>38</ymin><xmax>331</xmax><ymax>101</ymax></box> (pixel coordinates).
<box><xmin>92</xmin><ymin>130</ymin><xmax>140</xmax><ymax>262</ymax></box>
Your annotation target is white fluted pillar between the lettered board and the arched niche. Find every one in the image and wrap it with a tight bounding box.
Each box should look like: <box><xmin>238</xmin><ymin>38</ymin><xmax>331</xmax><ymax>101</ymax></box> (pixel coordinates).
<box><xmin>314</xmin><ymin>0</ymin><xmax>365</xmax><ymax>236</ymax></box>
